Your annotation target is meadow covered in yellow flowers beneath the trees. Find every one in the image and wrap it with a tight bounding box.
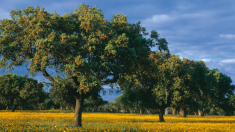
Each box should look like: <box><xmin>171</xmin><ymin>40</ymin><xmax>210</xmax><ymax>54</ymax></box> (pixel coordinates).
<box><xmin>0</xmin><ymin>110</ymin><xmax>235</xmax><ymax>132</ymax></box>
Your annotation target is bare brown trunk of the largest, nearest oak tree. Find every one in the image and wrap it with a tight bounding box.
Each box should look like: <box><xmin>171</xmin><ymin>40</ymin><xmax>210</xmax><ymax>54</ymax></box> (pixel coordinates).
<box><xmin>73</xmin><ymin>94</ymin><xmax>84</xmax><ymax>127</ymax></box>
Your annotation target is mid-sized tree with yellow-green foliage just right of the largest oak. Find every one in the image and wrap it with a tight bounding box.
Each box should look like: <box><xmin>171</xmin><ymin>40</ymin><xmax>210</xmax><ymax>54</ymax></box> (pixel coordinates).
<box><xmin>145</xmin><ymin>52</ymin><xmax>189</xmax><ymax>122</ymax></box>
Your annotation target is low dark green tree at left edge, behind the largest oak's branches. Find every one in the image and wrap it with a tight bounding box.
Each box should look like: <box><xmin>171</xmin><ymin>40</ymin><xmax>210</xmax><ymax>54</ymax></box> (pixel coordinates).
<box><xmin>0</xmin><ymin>74</ymin><xmax>43</xmax><ymax>112</ymax></box>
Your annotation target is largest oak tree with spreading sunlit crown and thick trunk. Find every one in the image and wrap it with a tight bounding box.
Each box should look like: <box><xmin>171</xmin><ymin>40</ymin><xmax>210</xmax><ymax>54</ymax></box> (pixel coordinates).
<box><xmin>0</xmin><ymin>4</ymin><xmax>164</xmax><ymax>127</ymax></box>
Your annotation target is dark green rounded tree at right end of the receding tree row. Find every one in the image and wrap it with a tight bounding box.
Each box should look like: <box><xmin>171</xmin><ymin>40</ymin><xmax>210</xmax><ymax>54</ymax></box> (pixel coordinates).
<box><xmin>193</xmin><ymin>69</ymin><xmax>234</xmax><ymax>116</ymax></box>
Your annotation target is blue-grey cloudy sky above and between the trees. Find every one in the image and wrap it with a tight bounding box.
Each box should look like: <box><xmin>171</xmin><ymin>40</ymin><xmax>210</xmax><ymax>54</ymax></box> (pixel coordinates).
<box><xmin>0</xmin><ymin>0</ymin><xmax>235</xmax><ymax>102</ymax></box>
